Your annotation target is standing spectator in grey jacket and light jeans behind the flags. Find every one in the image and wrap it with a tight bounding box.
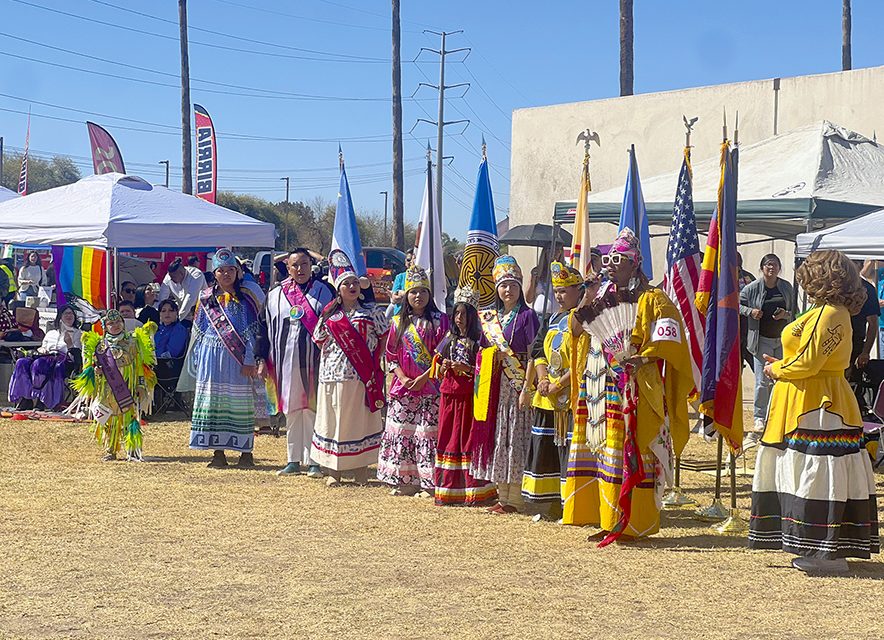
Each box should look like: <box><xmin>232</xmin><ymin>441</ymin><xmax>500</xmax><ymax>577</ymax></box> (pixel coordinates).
<box><xmin>740</xmin><ymin>253</ymin><xmax>795</xmax><ymax>448</ymax></box>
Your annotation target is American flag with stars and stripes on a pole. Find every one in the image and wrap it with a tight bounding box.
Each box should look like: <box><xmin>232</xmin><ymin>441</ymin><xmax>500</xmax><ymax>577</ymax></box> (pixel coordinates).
<box><xmin>663</xmin><ymin>149</ymin><xmax>706</xmax><ymax>389</ymax></box>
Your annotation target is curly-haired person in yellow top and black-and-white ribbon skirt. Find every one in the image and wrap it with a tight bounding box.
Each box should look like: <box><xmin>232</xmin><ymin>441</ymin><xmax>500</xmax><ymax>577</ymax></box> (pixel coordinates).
<box><xmin>749</xmin><ymin>251</ymin><xmax>878</xmax><ymax>573</ymax></box>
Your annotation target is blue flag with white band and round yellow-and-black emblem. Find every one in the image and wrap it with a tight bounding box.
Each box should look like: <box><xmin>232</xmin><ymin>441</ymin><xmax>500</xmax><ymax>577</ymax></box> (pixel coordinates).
<box><xmin>458</xmin><ymin>154</ymin><xmax>500</xmax><ymax>307</ymax></box>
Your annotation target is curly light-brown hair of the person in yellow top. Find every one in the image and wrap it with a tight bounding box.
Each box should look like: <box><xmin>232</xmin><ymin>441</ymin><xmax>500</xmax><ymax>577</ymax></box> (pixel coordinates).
<box><xmin>795</xmin><ymin>249</ymin><xmax>867</xmax><ymax>315</ymax></box>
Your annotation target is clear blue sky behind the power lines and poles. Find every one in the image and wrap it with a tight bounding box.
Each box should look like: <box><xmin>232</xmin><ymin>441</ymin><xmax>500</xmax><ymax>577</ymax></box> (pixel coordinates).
<box><xmin>0</xmin><ymin>0</ymin><xmax>884</xmax><ymax>238</ymax></box>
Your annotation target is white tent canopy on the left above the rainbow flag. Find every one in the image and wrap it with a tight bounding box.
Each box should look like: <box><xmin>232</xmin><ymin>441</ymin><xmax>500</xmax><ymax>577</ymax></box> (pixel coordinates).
<box><xmin>0</xmin><ymin>173</ymin><xmax>276</xmax><ymax>250</ymax></box>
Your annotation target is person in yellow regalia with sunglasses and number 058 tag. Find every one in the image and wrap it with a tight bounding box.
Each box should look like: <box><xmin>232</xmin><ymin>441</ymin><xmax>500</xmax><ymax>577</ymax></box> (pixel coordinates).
<box><xmin>565</xmin><ymin>228</ymin><xmax>694</xmax><ymax>546</ymax></box>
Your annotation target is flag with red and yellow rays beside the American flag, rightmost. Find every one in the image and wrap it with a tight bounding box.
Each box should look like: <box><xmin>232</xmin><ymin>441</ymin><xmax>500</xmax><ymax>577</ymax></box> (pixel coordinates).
<box><xmin>697</xmin><ymin>140</ymin><xmax>743</xmax><ymax>452</ymax></box>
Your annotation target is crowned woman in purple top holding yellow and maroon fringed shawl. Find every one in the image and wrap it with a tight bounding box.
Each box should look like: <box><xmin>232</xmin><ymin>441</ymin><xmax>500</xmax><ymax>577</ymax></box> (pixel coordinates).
<box><xmin>469</xmin><ymin>255</ymin><xmax>540</xmax><ymax>514</ymax></box>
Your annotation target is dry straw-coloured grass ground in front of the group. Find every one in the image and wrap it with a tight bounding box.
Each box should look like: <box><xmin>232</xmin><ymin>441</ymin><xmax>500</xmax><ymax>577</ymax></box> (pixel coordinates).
<box><xmin>0</xmin><ymin>420</ymin><xmax>884</xmax><ymax>639</ymax></box>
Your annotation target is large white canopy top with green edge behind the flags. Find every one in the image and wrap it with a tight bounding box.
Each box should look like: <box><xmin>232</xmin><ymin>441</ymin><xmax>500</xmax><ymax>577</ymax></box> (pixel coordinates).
<box><xmin>556</xmin><ymin>120</ymin><xmax>884</xmax><ymax>238</ymax></box>
